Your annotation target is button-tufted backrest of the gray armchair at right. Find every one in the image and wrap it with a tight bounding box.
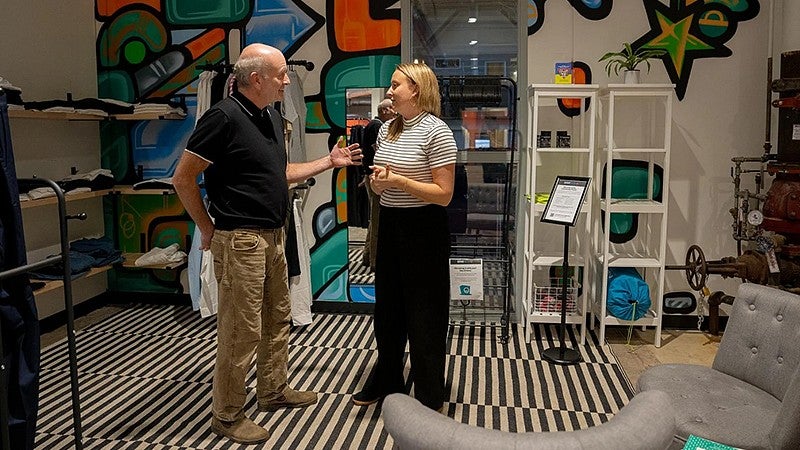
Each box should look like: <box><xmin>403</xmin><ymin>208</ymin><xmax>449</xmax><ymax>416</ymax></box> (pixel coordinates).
<box><xmin>712</xmin><ymin>283</ymin><xmax>800</xmax><ymax>448</ymax></box>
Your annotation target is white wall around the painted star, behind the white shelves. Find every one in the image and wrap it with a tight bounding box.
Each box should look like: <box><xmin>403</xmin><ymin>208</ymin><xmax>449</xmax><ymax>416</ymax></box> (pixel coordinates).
<box><xmin>523</xmin><ymin>0</ymin><xmax>772</xmax><ymax>298</ymax></box>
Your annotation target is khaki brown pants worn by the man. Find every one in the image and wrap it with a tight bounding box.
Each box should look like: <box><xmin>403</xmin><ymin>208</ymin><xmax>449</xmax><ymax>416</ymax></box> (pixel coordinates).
<box><xmin>211</xmin><ymin>229</ymin><xmax>291</xmax><ymax>422</ymax></box>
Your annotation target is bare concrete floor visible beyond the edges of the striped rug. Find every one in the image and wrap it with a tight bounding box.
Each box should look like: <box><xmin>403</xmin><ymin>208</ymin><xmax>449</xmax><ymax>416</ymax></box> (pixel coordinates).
<box><xmin>41</xmin><ymin>305</ymin><xmax>721</xmax><ymax>387</ymax></box>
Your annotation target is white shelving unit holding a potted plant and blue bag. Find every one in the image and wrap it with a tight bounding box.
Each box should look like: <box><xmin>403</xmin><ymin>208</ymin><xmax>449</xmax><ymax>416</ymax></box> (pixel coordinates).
<box><xmin>591</xmin><ymin>84</ymin><xmax>674</xmax><ymax>347</ymax></box>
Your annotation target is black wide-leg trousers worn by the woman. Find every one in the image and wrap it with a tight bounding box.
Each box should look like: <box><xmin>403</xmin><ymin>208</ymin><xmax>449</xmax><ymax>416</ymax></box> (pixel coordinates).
<box><xmin>371</xmin><ymin>205</ymin><xmax>450</xmax><ymax>409</ymax></box>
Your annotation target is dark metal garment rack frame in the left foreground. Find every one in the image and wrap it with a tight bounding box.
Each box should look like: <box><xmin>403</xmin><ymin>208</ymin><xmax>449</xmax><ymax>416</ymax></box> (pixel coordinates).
<box><xmin>0</xmin><ymin>178</ymin><xmax>86</xmax><ymax>450</ymax></box>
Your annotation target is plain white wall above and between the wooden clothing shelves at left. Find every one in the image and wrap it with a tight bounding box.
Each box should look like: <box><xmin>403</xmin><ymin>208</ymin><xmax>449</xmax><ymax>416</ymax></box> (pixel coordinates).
<box><xmin>0</xmin><ymin>0</ymin><xmax>106</xmax><ymax>318</ymax></box>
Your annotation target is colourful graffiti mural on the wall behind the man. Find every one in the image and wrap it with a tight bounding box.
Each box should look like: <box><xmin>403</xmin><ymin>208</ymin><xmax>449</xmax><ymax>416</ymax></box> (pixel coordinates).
<box><xmin>95</xmin><ymin>0</ymin><xmax>400</xmax><ymax>301</ymax></box>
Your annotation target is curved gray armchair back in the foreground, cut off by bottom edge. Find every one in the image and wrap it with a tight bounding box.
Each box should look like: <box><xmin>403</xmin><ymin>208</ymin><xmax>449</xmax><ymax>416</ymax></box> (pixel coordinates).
<box><xmin>382</xmin><ymin>392</ymin><xmax>675</xmax><ymax>450</ymax></box>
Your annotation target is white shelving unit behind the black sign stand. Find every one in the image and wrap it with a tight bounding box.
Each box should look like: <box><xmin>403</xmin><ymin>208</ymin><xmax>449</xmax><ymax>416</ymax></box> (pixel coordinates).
<box><xmin>521</xmin><ymin>84</ymin><xmax>598</xmax><ymax>344</ymax></box>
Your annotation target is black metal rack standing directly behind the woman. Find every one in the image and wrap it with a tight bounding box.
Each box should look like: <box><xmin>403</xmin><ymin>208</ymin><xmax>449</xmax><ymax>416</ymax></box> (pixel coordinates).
<box><xmin>438</xmin><ymin>75</ymin><xmax>518</xmax><ymax>343</ymax></box>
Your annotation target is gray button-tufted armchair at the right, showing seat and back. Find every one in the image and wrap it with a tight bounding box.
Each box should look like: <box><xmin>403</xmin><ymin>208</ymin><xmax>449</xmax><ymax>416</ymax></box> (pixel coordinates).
<box><xmin>638</xmin><ymin>283</ymin><xmax>800</xmax><ymax>449</ymax></box>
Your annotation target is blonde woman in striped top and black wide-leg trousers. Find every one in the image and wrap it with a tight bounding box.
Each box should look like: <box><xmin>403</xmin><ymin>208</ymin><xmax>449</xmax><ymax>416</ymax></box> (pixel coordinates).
<box><xmin>353</xmin><ymin>63</ymin><xmax>457</xmax><ymax>410</ymax></box>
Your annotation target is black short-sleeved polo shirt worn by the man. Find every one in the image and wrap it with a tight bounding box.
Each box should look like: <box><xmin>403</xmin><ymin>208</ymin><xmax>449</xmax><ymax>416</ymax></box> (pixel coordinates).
<box><xmin>186</xmin><ymin>92</ymin><xmax>289</xmax><ymax>230</ymax></box>
